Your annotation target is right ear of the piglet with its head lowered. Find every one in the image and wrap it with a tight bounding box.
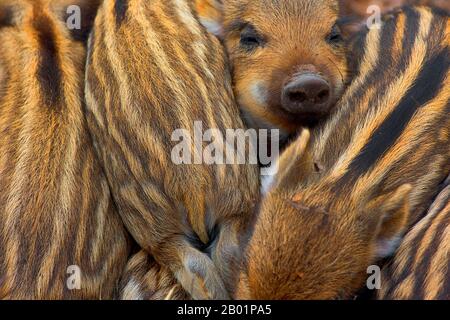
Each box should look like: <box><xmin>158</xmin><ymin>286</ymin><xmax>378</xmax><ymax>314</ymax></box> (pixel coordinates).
<box><xmin>366</xmin><ymin>184</ymin><xmax>412</xmax><ymax>258</ymax></box>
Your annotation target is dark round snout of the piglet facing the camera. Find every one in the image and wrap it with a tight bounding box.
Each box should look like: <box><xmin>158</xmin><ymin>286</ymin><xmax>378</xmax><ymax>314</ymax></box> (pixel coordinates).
<box><xmin>281</xmin><ymin>74</ymin><xmax>331</xmax><ymax>114</ymax></box>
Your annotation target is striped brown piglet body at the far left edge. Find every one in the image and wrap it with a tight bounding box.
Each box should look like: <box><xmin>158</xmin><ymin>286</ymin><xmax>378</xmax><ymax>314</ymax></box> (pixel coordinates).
<box><xmin>0</xmin><ymin>0</ymin><xmax>129</xmax><ymax>299</ymax></box>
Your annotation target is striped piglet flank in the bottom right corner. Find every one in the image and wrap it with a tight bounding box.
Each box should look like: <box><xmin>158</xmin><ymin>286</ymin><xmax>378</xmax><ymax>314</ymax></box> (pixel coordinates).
<box><xmin>378</xmin><ymin>177</ymin><xmax>450</xmax><ymax>300</ymax></box>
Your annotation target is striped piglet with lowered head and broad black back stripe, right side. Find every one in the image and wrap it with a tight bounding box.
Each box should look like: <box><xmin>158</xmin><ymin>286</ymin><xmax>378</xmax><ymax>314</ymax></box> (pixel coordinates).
<box><xmin>237</xmin><ymin>7</ymin><xmax>450</xmax><ymax>299</ymax></box>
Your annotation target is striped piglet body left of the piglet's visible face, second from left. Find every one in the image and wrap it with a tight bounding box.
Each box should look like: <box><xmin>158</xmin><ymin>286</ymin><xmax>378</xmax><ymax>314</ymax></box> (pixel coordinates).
<box><xmin>86</xmin><ymin>0</ymin><xmax>259</xmax><ymax>299</ymax></box>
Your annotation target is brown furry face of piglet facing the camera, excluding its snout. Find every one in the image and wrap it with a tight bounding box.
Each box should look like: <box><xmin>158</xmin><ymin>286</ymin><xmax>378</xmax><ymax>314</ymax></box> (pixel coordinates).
<box><xmin>196</xmin><ymin>0</ymin><xmax>348</xmax><ymax>134</ymax></box>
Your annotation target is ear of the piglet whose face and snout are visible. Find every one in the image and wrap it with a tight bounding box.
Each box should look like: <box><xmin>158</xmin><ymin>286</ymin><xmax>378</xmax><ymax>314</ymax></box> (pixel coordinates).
<box><xmin>195</xmin><ymin>0</ymin><xmax>224</xmax><ymax>39</ymax></box>
